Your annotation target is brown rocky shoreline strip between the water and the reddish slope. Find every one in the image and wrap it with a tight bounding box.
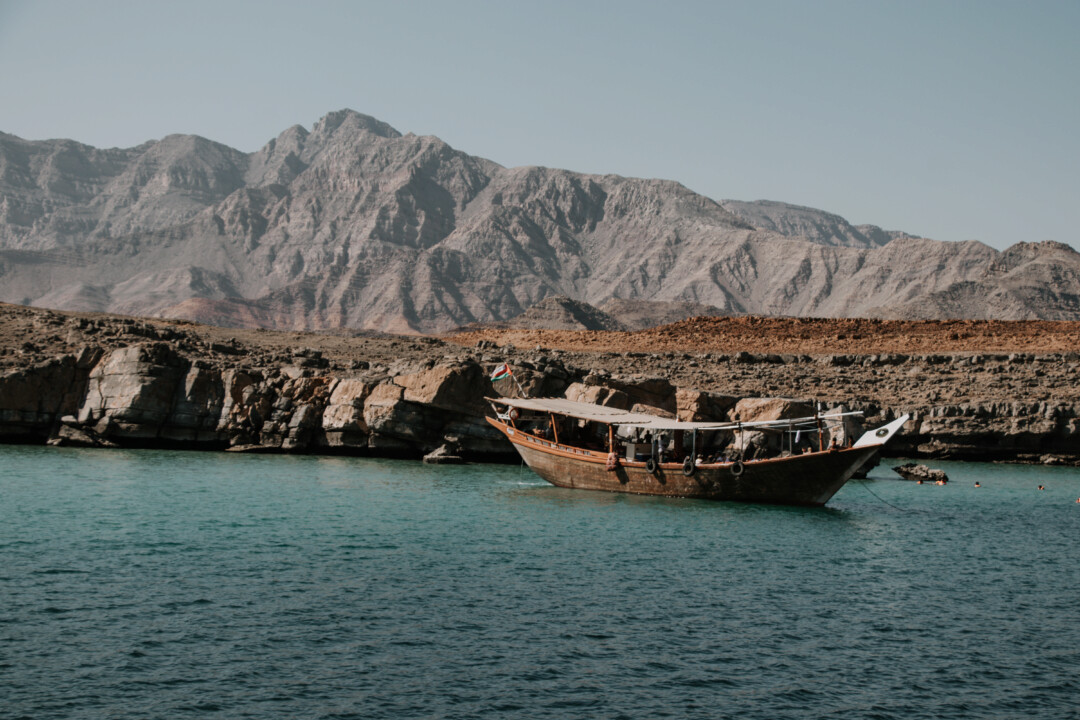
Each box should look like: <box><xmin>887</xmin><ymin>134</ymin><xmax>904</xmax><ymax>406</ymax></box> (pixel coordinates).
<box><xmin>0</xmin><ymin>305</ymin><xmax>1080</xmax><ymax>465</ymax></box>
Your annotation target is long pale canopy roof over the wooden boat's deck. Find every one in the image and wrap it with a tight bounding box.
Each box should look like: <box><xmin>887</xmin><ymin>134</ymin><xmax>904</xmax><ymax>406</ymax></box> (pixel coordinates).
<box><xmin>486</xmin><ymin>397</ymin><xmax>862</xmax><ymax>431</ymax></box>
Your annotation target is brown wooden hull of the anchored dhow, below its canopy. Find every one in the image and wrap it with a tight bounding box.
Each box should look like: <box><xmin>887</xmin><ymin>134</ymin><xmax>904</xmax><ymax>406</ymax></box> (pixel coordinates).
<box><xmin>488</xmin><ymin>418</ymin><xmax>880</xmax><ymax>506</ymax></box>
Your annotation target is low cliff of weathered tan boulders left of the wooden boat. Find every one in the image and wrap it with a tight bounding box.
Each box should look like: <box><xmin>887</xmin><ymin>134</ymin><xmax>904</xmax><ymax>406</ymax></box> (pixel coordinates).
<box><xmin>7</xmin><ymin>342</ymin><xmax>522</xmax><ymax>459</ymax></box>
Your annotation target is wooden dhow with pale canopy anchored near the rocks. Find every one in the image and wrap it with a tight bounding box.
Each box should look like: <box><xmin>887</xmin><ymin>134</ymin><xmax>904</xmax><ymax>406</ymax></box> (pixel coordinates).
<box><xmin>486</xmin><ymin>397</ymin><xmax>908</xmax><ymax>505</ymax></box>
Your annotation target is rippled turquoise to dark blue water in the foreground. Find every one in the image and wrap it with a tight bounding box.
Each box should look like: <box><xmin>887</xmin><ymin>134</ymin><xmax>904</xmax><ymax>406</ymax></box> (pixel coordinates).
<box><xmin>0</xmin><ymin>446</ymin><xmax>1080</xmax><ymax>720</ymax></box>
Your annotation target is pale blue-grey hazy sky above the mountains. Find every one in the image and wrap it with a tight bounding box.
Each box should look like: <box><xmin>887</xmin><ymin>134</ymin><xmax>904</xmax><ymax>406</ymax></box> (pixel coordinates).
<box><xmin>0</xmin><ymin>0</ymin><xmax>1080</xmax><ymax>248</ymax></box>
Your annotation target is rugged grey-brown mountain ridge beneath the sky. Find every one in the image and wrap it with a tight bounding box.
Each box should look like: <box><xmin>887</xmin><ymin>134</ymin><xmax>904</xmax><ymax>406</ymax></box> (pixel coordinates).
<box><xmin>0</xmin><ymin>110</ymin><xmax>1080</xmax><ymax>332</ymax></box>
